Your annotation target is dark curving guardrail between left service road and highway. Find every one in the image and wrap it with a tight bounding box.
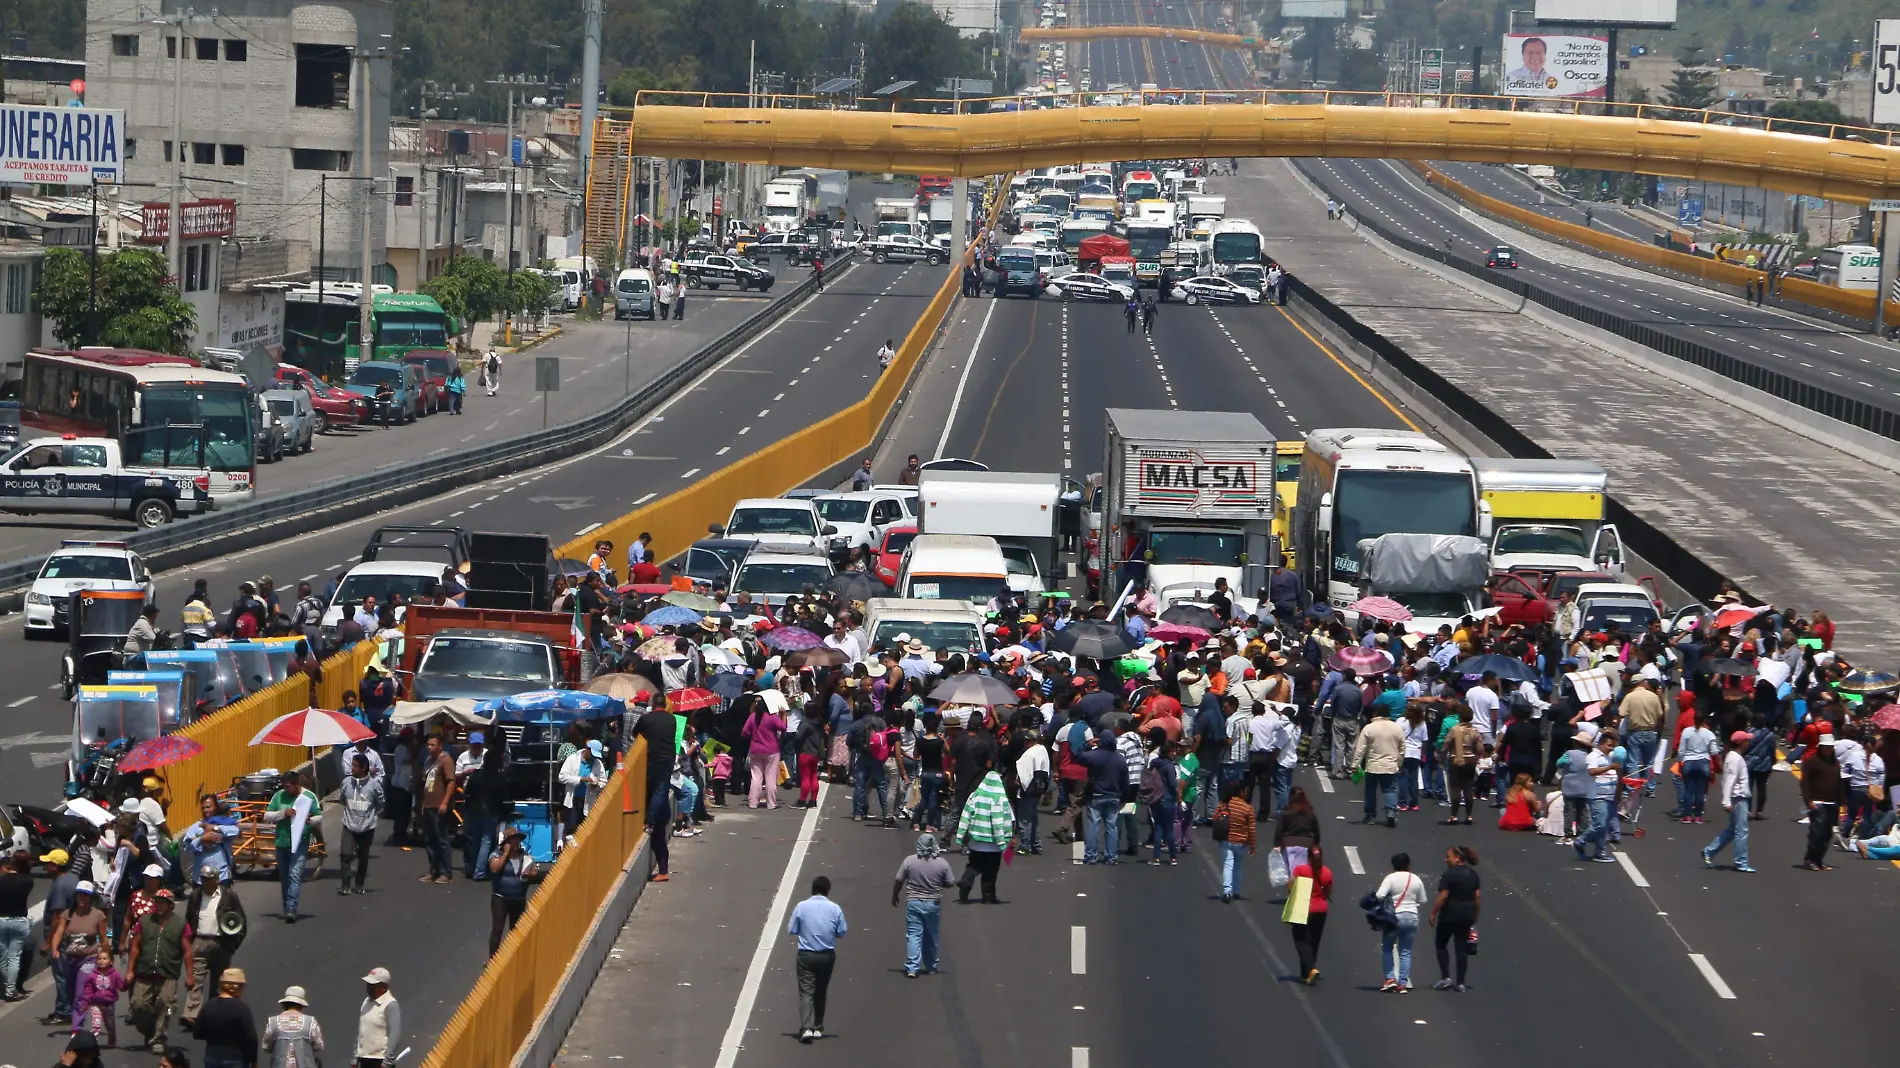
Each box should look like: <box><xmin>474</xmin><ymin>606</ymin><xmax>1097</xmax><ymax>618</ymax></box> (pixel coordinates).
<box><xmin>0</xmin><ymin>249</ymin><xmax>855</xmax><ymax>591</ymax></box>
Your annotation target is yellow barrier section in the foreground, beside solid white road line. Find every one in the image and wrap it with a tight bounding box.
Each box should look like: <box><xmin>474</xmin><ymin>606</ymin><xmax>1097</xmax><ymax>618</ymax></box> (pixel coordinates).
<box><xmin>422</xmin><ymin>741</ymin><xmax>646</xmax><ymax>1068</ymax></box>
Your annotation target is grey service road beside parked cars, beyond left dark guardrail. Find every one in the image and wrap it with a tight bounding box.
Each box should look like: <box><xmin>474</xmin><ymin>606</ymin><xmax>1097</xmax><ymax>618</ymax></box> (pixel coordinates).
<box><xmin>0</xmin><ymin>283</ymin><xmax>804</xmax><ymax>561</ymax></box>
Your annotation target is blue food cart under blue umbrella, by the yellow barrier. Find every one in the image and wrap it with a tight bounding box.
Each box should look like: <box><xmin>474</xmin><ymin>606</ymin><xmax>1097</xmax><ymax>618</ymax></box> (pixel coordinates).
<box><xmin>475</xmin><ymin>690</ymin><xmax>627</xmax><ymax>863</ymax></box>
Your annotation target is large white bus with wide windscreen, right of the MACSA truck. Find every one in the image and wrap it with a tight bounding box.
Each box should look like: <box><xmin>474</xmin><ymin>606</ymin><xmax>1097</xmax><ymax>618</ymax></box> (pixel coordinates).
<box><xmin>1292</xmin><ymin>428</ymin><xmax>1492</xmax><ymax>612</ymax></box>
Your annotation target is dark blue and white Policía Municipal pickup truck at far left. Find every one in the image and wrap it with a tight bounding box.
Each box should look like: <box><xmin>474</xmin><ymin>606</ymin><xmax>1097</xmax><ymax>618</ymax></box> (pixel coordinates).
<box><xmin>0</xmin><ymin>437</ymin><xmax>217</xmax><ymax>526</ymax></box>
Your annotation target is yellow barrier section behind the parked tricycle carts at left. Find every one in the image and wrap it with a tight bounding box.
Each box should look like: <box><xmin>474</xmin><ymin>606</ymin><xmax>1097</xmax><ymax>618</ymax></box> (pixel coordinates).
<box><xmin>160</xmin><ymin>642</ymin><xmax>376</xmax><ymax>830</ymax></box>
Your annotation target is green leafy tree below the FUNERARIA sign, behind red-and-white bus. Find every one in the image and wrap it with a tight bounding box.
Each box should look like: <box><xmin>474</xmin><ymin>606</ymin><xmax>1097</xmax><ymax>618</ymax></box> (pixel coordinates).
<box><xmin>34</xmin><ymin>249</ymin><xmax>198</xmax><ymax>355</ymax></box>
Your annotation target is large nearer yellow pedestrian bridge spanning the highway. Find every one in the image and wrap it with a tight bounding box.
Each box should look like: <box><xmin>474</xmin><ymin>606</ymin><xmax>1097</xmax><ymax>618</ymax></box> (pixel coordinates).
<box><xmin>611</xmin><ymin>89</ymin><xmax>1900</xmax><ymax>203</ymax></box>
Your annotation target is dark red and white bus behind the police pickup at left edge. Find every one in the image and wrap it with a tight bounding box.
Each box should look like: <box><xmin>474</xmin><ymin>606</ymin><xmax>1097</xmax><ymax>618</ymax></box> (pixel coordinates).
<box><xmin>19</xmin><ymin>348</ymin><xmax>257</xmax><ymax>505</ymax></box>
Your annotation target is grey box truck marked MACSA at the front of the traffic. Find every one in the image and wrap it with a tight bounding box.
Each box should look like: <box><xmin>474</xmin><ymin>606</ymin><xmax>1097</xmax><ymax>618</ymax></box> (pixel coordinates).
<box><xmin>1091</xmin><ymin>409</ymin><xmax>1279</xmax><ymax>612</ymax></box>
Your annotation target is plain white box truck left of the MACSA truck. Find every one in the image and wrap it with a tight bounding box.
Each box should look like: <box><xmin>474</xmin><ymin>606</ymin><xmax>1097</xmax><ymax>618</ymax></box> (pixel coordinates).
<box><xmin>918</xmin><ymin>471</ymin><xmax>1062</xmax><ymax>593</ymax></box>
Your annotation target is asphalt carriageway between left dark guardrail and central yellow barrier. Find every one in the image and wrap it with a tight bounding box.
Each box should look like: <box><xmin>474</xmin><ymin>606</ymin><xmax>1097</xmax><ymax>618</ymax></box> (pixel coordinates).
<box><xmin>0</xmin><ymin>256</ymin><xmax>944</xmax><ymax>1064</ymax></box>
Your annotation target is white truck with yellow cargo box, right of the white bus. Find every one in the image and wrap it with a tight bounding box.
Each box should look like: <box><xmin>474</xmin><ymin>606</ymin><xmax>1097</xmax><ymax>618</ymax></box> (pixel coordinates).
<box><xmin>1471</xmin><ymin>458</ymin><xmax>1623</xmax><ymax>576</ymax></box>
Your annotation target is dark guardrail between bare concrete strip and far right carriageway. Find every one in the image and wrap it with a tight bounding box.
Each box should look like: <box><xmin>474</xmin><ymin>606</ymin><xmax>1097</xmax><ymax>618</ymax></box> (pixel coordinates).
<box><xmin>1355</xmin><ymin>203</ymin><xmax>1900</xmax><ymax>441</ymax></box>
